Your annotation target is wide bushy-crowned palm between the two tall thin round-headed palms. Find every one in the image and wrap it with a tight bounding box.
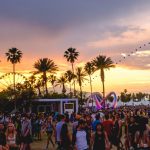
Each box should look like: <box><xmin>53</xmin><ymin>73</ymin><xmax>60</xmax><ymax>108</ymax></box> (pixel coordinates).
<box><xmin>34</xmin><ymin>58</ymin><xmax>58</xmax><ymax>95</ymax></box>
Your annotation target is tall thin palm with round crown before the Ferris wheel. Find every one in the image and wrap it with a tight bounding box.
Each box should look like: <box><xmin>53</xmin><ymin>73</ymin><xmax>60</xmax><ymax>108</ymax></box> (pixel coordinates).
<box><xmin>5</xmin><ymin>48</ymin><xmax>22</xmax><ymax>91</ymax></box>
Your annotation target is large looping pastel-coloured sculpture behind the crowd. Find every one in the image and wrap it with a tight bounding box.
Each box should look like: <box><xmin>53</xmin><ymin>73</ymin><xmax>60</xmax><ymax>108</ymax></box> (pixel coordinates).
<box><xmin>87</xmin><ymin>92</ymin><xmax>117</xmax><ymax>110</ymax></box>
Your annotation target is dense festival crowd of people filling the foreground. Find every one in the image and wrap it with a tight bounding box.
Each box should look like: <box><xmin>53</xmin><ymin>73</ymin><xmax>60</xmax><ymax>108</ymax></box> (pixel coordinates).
<box><xmin>0</xmin><ymin>106</ymin><xmax>150</xmax><ymax>150</ymax></box>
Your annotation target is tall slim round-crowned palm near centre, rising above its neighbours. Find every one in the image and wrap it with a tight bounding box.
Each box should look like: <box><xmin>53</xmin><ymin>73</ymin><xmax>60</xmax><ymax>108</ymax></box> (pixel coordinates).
<box><xmin>64</xmin><ymin>47</ymin><xmax>79</xmax><ymax>95</ymax></box>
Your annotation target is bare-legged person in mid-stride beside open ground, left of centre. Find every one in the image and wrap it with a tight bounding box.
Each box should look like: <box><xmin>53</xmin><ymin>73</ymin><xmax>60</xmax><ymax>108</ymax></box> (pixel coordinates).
<box><xmin>46</xmin><ymin>116</ymin><xmax>55</xmax><ymax>149</ymax></box>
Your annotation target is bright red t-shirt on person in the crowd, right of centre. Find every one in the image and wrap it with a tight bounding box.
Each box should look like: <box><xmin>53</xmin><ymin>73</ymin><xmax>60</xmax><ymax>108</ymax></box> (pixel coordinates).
<box><xmin>103</xmin><ymin>120</ymin><xmax>113</xmax><ymax>136</ymax></box>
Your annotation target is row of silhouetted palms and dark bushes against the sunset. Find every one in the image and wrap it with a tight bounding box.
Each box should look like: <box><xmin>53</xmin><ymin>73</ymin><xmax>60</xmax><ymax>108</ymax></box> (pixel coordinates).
<box><xmin>0</xmin><ymin>47</ymin><xmax>148</xmax><ymax>111</ymax></box>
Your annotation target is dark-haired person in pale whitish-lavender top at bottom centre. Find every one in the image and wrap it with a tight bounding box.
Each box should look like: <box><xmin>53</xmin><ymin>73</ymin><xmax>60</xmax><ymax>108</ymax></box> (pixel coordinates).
<box><xmin>72</xmin><ymin>119</ymin><xmax>90</xmax><ymax>150</ymax></box>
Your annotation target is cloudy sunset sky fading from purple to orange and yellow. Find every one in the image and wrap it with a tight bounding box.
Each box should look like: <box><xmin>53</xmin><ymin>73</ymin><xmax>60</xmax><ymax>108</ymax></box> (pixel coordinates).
<box><xmin>0</xmin><ymin>0</ymin><xmax>150</xmax><ymax>93</ymax></box>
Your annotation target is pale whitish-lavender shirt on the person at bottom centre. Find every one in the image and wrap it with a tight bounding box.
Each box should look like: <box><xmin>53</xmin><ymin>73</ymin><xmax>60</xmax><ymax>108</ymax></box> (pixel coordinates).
<box><xmin>76</xmin><ymin>130</ymin><xmax>88</xmax><ymax>150</ymax></box>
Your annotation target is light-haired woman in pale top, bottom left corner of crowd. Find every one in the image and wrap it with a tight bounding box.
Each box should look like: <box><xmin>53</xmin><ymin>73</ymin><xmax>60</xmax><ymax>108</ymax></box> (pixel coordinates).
<box><xmin>6</xmin><ymin>123</ymin><xmax>19</xmax><ymax>150</ymax></box>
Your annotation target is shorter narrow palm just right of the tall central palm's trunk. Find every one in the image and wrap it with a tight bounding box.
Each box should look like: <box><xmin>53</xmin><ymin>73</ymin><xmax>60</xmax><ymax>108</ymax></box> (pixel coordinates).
<box><xmin>76</xmin><ymin>67</ymin><xmax>86</xmax><ymax>101</ymax></box>
